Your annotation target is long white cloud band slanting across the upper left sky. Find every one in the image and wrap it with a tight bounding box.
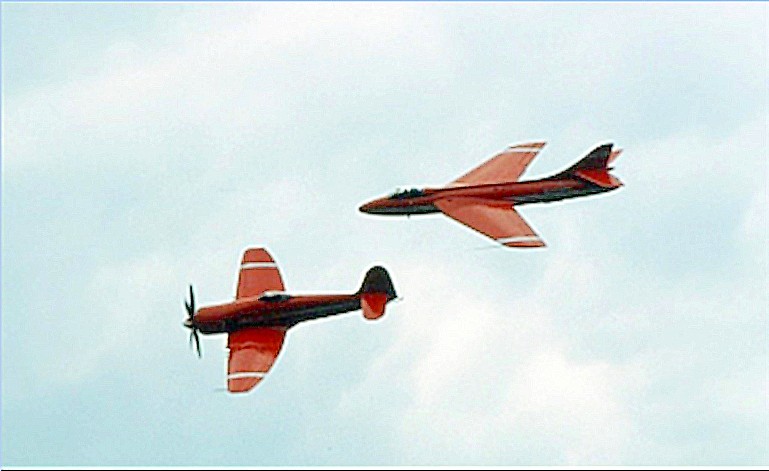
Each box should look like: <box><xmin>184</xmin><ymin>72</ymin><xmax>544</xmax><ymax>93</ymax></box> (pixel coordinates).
<box><xmin>4</xmin><ymin>4</ymin><xmax>450</xmax><ymax>172</ymax></box>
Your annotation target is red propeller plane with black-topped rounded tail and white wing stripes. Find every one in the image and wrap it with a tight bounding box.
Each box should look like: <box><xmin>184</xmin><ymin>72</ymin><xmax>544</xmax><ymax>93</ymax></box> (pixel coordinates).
<box><xmin>184</xmin><ymin>248</ymin><xmax>397</xmax><ymax>393</ymax></box>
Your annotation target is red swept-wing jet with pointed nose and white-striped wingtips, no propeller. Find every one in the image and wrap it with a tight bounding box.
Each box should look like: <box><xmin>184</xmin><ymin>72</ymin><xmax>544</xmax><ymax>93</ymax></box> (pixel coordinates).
<box><xmin>360</xmin><ymin>142</ymin><xmax>622</xmax><ymax>247</ymax></box>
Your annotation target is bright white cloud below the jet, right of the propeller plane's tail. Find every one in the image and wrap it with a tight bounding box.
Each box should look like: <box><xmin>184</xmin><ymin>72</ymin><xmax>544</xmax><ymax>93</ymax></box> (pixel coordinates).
<box><xmin>339</xmin><ymin>254</ymin><xmax>641</xmax><ymax>464</ymax></box>
